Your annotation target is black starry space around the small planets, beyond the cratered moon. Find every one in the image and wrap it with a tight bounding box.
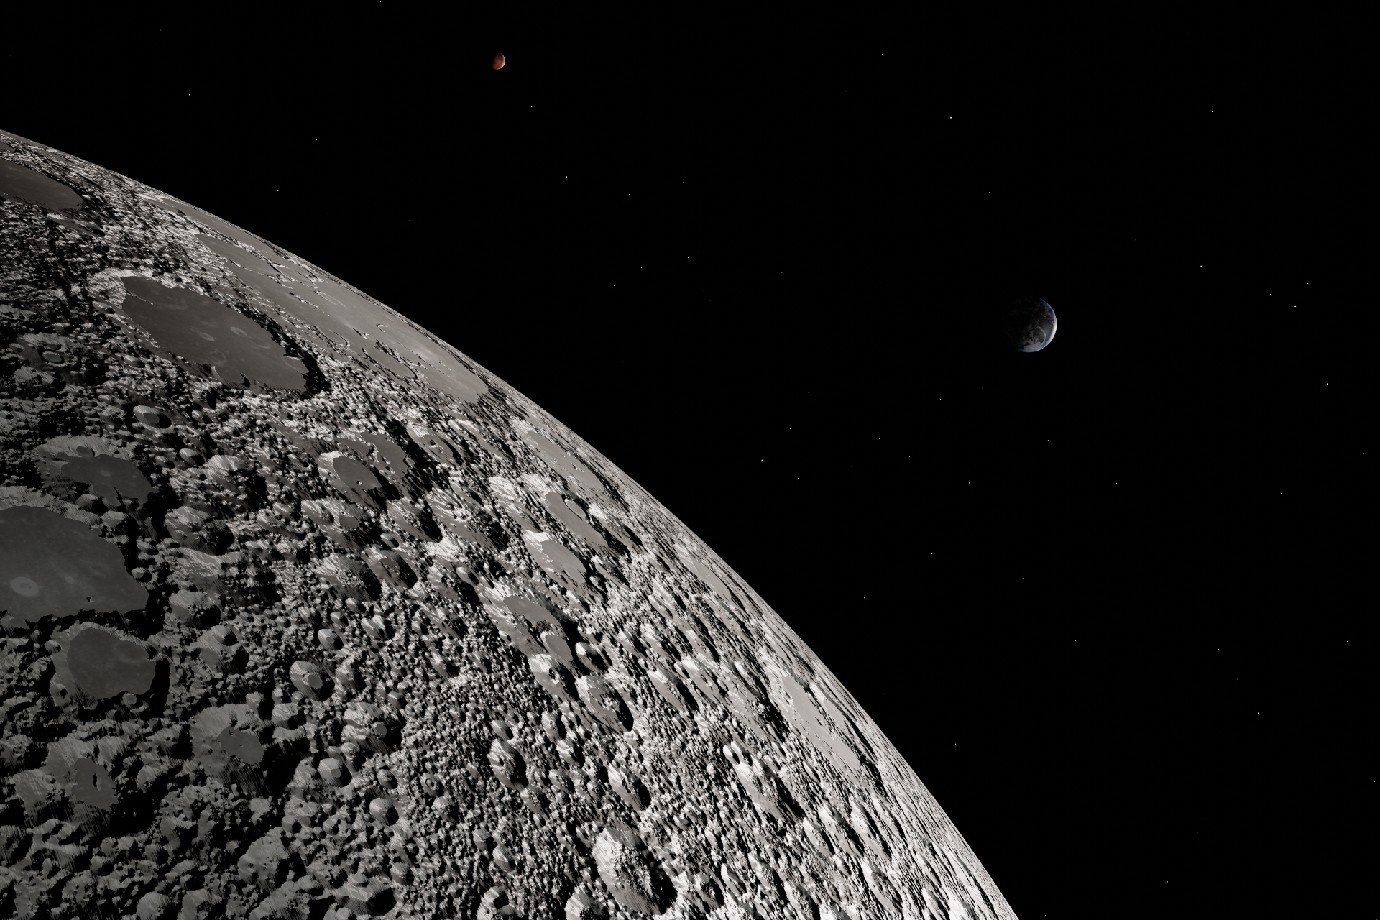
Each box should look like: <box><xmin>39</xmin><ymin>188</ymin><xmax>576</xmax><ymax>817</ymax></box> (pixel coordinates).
<box><xmin>0</xmin><ymin>3</ymin><xmax>1380</xmax><ymax>919</ymax></box>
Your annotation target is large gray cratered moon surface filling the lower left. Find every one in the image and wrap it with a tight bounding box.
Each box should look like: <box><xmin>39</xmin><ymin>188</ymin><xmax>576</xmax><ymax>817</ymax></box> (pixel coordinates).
<box><xmin>0</xmin><ymin>135</ymin><xmax>1013</xmax><ymax>920</ymax></box>
